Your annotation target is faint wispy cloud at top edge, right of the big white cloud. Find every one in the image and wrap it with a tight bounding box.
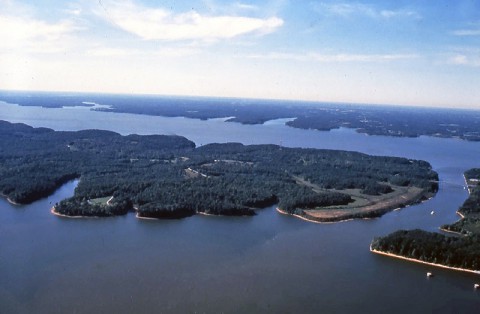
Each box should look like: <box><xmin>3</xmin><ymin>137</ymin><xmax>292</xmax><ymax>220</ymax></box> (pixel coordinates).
<box><xmin>314</xmin><ymin>2</ymin><xmax>420</xmax><ymax>19</ymax></box>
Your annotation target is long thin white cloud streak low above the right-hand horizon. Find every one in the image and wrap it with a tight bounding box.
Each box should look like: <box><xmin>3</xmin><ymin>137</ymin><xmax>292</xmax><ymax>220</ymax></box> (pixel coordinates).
<box><xmin>249</xmin><ymin>52</ymin><xmax>419</xmax><ymax>63</ymax></box>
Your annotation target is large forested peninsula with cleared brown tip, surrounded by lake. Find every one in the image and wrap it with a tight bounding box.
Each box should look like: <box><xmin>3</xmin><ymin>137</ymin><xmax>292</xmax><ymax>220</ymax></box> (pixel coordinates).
<box><xmin>0</xmin><ymin>121</ymin><xmax>438</xmax><ymax>221</ymax></box>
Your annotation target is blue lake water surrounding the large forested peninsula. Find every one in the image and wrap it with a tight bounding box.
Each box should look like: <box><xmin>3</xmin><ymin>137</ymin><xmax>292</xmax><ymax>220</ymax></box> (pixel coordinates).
<box><xmin>0</xmin><ymin>99</ymin><xmax>480</xmax><ymax>313</ymax></box>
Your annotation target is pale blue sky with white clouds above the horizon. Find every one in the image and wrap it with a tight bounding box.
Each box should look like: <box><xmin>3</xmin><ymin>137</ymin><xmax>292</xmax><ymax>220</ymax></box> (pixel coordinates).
<box><xmin>0</xmin><ymin>0</ymin><xmax>480</xmax><ymax>109</ymax></box>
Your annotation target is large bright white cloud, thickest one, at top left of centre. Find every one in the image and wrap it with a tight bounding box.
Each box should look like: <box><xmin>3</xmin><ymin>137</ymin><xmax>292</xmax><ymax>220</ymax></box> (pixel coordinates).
<box><xmin>97</xmin><ymin>1</ymin><xmax>283</xmax><ymax>41</ymax></box>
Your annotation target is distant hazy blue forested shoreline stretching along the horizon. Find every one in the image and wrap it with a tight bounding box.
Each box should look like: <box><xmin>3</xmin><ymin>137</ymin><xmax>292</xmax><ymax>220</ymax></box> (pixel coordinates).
<box><xmin>0</xmin><ymin>91</ymin><xmax>480</xmax><ymax>141</ymax></box>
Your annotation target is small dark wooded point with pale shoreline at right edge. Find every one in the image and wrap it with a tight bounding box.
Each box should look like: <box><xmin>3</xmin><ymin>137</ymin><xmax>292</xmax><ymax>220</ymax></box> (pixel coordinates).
<box><xmin>371</xmin><ymin>168</ymin><xmax>480</xmax><ymax>274</ymax></box>
